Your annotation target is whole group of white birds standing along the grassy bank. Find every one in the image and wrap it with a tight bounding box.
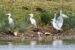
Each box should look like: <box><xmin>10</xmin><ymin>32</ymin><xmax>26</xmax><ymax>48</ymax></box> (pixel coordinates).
<box><xmin>7</xmin><ymin>10</ymin><xmax>68</xmax><ymax>31</ymax></box>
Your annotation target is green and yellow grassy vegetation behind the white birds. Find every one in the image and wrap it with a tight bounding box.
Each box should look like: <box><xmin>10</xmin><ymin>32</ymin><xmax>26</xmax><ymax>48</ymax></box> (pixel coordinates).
<box><xmin>0</xmin><ymin>0</ymin><xmax>75</xmax><ymax>32</ymax></box>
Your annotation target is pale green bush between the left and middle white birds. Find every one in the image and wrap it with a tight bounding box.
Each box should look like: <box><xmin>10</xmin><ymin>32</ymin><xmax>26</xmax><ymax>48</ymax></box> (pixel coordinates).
<box><xmin>15</xmin><ymin>14</ymin><xmax>30</xmax><ymax>32</ymax></box>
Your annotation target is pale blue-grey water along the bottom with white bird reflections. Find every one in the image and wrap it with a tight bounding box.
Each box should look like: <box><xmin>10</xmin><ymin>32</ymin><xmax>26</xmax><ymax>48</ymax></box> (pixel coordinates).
<box><xmin>0</xmin><ymin>40</ymin><xmax>75</xmax><ymax>50</ymax></box>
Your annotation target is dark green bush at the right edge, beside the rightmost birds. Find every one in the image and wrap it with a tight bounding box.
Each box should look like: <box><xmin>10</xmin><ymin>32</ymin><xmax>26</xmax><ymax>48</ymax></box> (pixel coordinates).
<box><xmin>64</xmin><ymin>15</ymin><xmax>75</xmax><ymax>29</ymax></box>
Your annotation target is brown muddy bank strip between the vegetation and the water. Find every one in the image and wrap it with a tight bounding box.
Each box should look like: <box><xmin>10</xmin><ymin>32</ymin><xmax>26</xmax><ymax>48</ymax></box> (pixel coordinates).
<box><xmin>0</xmin><ymin>29</ymin><xmax>75</xmax><ymax>42</ymax></box>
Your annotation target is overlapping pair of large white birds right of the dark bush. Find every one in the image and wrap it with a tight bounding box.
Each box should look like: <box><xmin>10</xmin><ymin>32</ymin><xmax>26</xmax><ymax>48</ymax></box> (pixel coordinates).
<box><xmin>51</xmin><ymin>10</ymin><xmax>68</xmax><ymax>31</ymax></box>
